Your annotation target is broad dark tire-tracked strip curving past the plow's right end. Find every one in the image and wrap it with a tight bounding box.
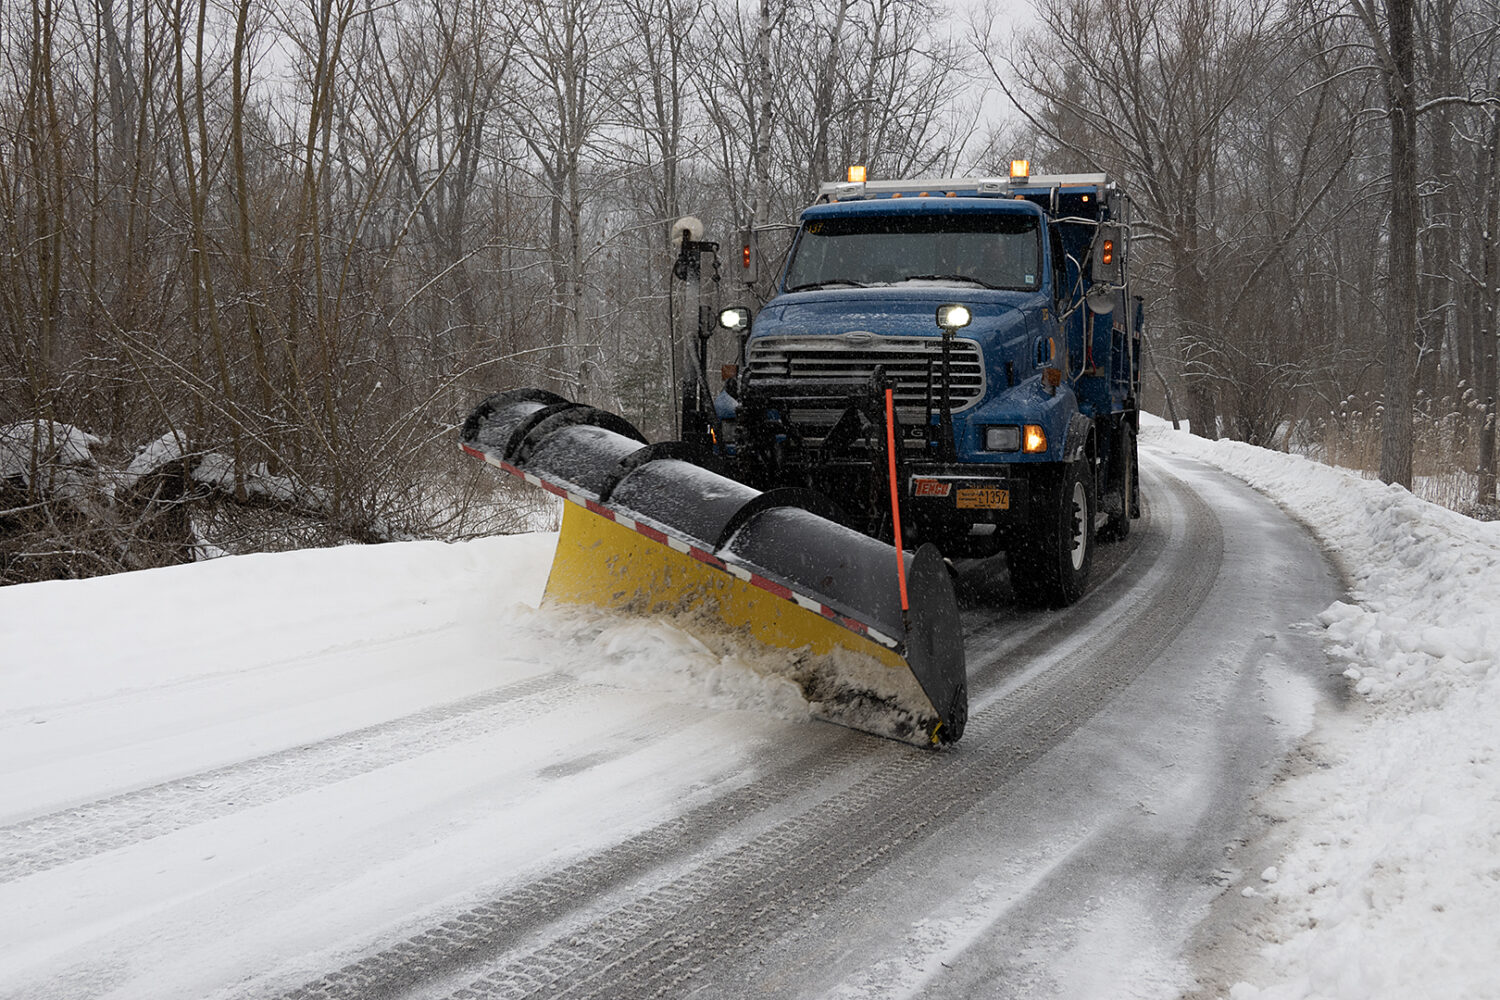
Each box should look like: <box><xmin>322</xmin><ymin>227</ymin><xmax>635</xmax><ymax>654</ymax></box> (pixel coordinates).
<box><xmin>276</xmin><ymin>464</ymin><xmax>1224</xmax><ymax>1000</ymax></box>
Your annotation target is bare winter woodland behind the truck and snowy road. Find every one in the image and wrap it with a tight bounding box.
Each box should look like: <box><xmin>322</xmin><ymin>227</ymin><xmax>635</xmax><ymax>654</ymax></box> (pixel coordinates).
<box><xmin>0</xmin><ymin>0</ymin><xmax>1500</xmax><ymax>583</ymax></box>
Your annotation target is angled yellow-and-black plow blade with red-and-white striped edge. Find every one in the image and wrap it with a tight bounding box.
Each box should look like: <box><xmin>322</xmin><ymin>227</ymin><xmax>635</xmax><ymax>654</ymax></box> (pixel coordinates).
<box><xmin>459</xmin><ymin>390</ymin><xmax>968</xmax><ymax>745</ymax></box>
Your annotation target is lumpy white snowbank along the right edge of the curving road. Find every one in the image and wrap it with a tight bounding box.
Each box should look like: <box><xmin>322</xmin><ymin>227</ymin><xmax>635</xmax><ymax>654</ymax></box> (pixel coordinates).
<box><xmin>1142</xmin><ymin>420</ymin><xmax>1500</xmax><ymax>1000</ymax></box>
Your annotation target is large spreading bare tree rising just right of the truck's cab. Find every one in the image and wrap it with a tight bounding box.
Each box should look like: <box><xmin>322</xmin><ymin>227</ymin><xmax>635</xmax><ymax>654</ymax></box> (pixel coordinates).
<box><xmin>972</xmin><ymin>0</ymin><xmax>1352</xmax><ymax>436</ymax></box>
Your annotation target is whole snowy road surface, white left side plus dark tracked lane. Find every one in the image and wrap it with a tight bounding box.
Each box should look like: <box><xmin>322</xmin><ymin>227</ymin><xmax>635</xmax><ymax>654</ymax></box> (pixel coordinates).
<box><xmin>0</xmin><ymin>450</ymin><xmax>1343</xmax><ymax>1000</ymax></box>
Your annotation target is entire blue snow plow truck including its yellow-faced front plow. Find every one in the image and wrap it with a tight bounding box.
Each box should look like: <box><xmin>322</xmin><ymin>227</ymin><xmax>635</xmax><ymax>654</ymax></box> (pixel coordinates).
<box><xmin>459</xmin><ymin>165</ymin><xmax>1143</xmax><ymax>745</ymax></box>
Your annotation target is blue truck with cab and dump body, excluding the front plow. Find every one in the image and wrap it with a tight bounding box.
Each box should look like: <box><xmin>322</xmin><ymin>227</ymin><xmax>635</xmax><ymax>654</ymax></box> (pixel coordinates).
<box><xmin>710</xmin><ymin>163</ymin><xmax>1143</xmax><ymax>607</ymax></box>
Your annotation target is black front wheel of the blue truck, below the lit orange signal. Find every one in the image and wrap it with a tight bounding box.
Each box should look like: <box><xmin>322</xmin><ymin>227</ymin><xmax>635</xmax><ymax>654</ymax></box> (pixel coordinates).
<box><xmin>1005</xmin><ymin>459</ymin><xmax>1097</xmax><ymax>607</ymax></box>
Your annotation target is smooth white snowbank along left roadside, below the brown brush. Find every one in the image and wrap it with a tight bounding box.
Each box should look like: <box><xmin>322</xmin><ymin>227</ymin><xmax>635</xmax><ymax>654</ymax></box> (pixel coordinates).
<box><xmin>0</xmin><ymin>535</ymin><xmax>557</xmax><ymax>712</ymax></box>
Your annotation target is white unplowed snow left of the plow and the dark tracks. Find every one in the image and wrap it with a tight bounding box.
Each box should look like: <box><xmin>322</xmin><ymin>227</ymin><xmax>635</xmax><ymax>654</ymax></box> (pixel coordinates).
<box><xmin>0</xmin><ymin>534</ymin><xmax>807</xmax><ymax>1000</ymax></box>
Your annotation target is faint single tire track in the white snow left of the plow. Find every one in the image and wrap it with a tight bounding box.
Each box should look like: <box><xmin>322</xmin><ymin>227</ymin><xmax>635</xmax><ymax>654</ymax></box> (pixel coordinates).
<box><xmin>0</xmin><ymin>673</ymin><xmax>575</xmax><ymax>885</ymax></box>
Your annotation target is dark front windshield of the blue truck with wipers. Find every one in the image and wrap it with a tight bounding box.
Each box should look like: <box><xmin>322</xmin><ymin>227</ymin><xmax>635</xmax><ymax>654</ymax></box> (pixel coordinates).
<box><xmin>786</xmin><ymin>211</ymin><xmax>1041</xmax><ymax>291</ymax></box>
